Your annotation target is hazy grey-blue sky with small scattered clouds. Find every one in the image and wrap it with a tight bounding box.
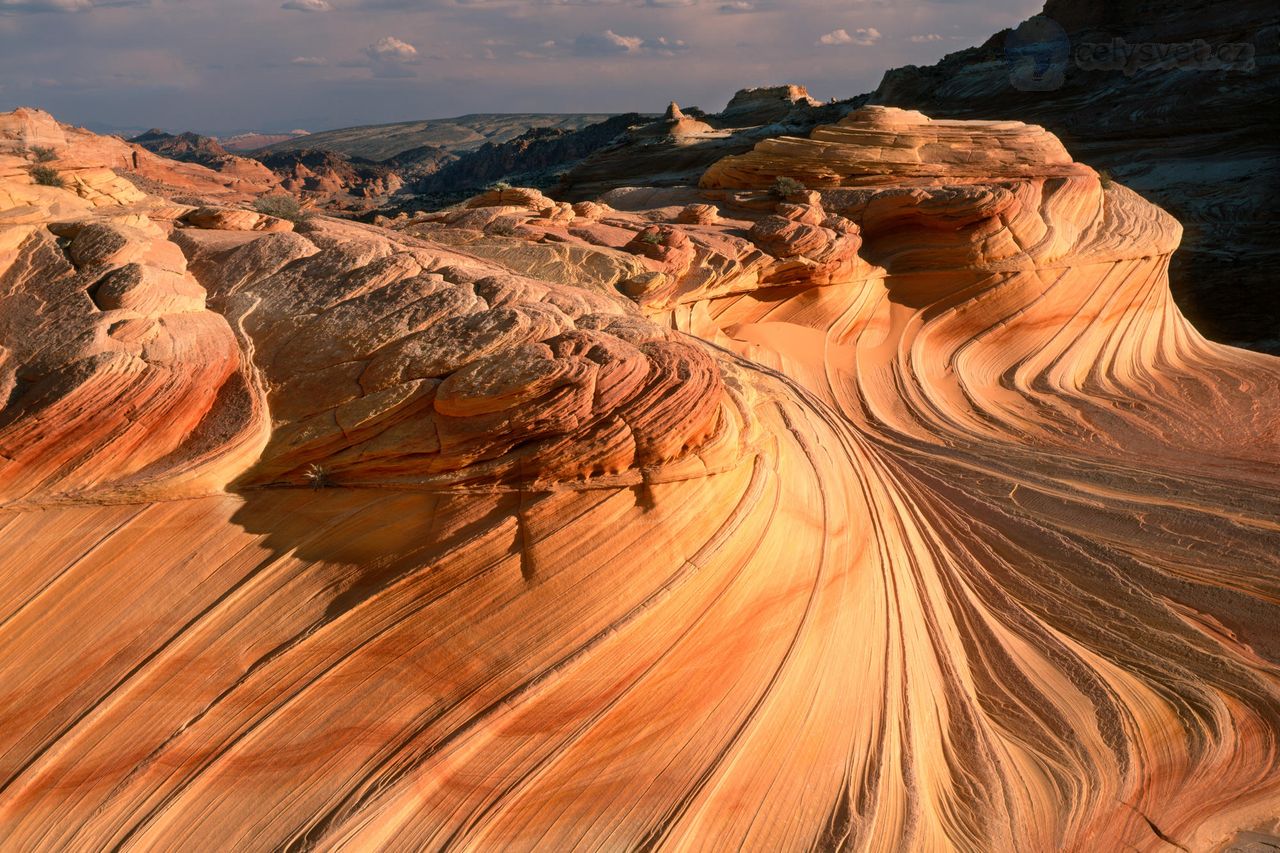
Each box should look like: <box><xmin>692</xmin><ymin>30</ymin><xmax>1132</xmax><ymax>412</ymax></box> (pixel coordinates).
<box><xmin>0</xmin><ymin>0</ymin><xmax>1042</xmax><ymax>133</ymax></box>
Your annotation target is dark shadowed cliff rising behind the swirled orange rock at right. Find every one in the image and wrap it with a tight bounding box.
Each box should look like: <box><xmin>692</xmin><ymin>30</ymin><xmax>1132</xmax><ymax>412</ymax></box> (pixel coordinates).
<box><xmin>870</xmin><ymin>0</ymin><xmax>1280</xmax><ymax>352</ymax></box>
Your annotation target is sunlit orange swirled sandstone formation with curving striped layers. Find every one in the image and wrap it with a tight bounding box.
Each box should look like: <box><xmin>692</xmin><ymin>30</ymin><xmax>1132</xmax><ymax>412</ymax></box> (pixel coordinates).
<box><xmin>0</xmin><ymin>108</ymin><xmax>1280</xmax><ymax>850</ymax></box>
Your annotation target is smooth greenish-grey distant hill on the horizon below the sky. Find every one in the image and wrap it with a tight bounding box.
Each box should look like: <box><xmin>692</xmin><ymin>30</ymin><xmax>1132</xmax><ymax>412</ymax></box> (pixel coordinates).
<box><xmin>254</xmin><ymin>113</ymin><xmax>611</xmax><ymax>160</ymax></box>
